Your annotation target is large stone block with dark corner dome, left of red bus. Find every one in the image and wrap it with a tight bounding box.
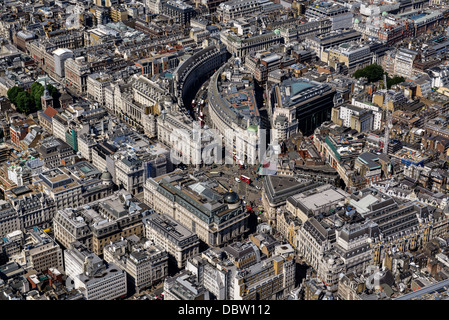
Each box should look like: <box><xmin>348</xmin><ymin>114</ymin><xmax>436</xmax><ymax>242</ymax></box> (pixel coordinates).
<box><xmin>144</xmin><ymin>169</ymin><xmax>249</xmax><ymax>246</ymax></box>
